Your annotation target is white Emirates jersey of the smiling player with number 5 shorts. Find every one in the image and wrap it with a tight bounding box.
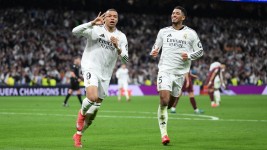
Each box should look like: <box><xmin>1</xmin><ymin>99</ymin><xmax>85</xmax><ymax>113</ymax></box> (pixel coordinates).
<box><xmin>152</xmin><ymin>26</ymin><xmax>203</xmax><ymax>74</ymax></box>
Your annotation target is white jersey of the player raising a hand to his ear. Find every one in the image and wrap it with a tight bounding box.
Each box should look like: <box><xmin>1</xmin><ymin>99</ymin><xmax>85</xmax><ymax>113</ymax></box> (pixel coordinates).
<box><xmin>72</xmin><ymin>22</ymin><xmax>128</xmax><ymax>80</ymax></box>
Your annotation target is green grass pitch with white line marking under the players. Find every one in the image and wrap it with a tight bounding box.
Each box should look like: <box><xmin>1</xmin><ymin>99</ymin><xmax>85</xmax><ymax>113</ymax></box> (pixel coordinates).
<box><xmin>0</xmin><ymin>95</ymin><xmax>267</xmax><ymax>150</ymax></box>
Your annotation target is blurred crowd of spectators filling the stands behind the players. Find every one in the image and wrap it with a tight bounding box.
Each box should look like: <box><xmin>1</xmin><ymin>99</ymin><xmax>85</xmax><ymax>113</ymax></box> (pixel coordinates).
<box><xmin>0</xmin><ymin>8</ymin><xmax>267</xmax><ymax>86</ymax></box>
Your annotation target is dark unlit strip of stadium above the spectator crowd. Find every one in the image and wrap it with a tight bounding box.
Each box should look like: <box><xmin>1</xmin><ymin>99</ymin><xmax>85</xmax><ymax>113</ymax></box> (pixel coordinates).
<box><xmin>0</xmin><ymin>0</ymin><xmax>267</xmax><ymax>20</ymax></box>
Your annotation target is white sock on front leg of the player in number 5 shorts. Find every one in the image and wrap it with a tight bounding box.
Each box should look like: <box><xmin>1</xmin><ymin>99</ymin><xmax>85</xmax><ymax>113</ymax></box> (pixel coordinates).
<box><xmin>158</xmin><ymin>105</ymin><xmax>168</xmax><ymax>137</ymax></box>
